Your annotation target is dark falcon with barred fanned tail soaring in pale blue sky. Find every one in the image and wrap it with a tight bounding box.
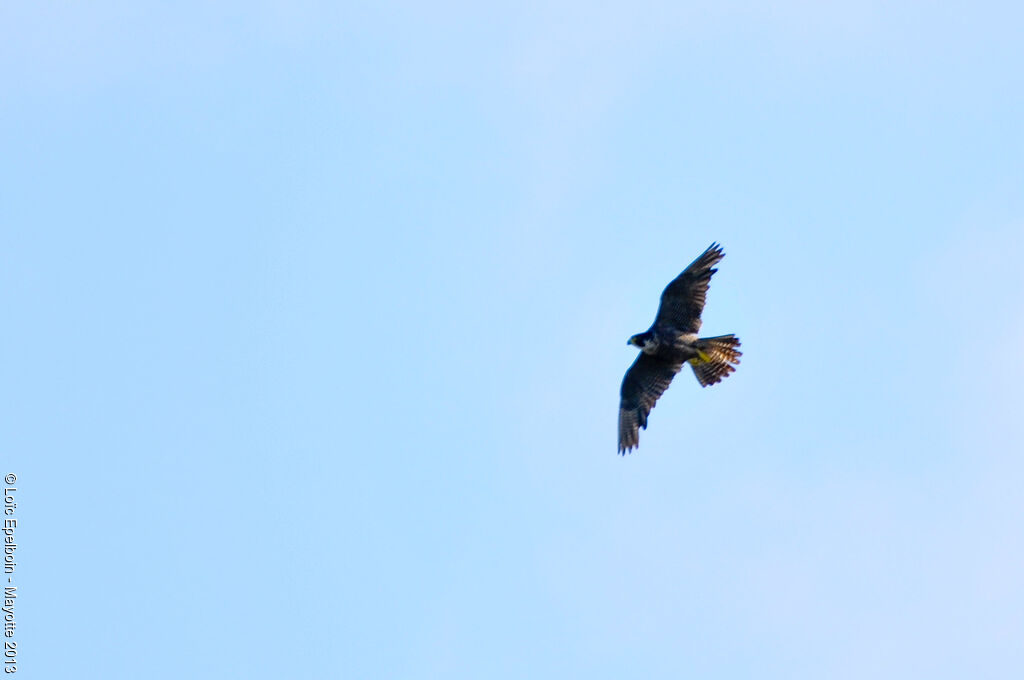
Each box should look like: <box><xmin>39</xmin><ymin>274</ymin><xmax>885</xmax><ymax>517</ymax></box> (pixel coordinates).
<box><xmin>618</xmin><ymin>243</ymin><xmax>742</xmax><ymax>455</ymax></box>
